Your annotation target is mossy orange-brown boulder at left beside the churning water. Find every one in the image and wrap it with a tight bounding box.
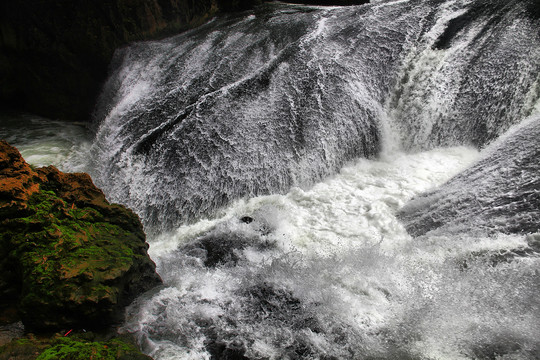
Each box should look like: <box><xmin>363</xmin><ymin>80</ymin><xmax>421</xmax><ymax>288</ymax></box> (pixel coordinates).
<box><xmin>0</xmin><ymin>141</ymin><xmax>161</xmax><ymax>330</ymax></box>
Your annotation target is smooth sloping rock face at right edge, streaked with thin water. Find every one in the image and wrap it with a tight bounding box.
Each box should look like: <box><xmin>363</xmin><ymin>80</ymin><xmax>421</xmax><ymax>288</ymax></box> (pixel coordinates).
<box><xmin>398</xmin><ymin>115</ymin><xmax>540</xmax><ymax>238</ymax></box>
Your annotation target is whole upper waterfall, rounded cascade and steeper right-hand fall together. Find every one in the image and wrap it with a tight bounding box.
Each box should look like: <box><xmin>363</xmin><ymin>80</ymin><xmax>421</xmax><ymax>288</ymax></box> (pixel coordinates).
<box><xmin>92</xmin><ymin>1</ymin><xmax>540</xmax><ymax>231</ymax></box>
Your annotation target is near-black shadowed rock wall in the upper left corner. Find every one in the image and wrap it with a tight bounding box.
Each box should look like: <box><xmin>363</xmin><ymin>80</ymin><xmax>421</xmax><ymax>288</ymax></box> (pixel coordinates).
<box><xmin>0</xmin><ymin>0</ymin><xmax>217</xmax><ymax>121</ymax></box>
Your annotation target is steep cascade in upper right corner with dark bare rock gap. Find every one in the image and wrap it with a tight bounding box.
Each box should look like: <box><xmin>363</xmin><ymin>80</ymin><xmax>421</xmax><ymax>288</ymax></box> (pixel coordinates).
<box><xmin>389</xmin><ymin>1</ymin><xmax>540</xmax><ymax>149</ymax></box>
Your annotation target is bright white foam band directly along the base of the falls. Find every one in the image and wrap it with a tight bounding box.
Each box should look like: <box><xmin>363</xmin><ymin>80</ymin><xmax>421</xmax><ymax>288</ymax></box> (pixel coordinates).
<box><xmin>150</xmin><ymin>147</ymin><xmax>478</xmax><ymax>257</ymax></box>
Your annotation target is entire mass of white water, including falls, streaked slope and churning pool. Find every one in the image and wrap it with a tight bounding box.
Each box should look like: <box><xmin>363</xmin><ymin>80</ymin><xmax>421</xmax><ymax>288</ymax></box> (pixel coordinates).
<box><xmin>0</xmin><ymin>0</ymin><xmax>540</xmax><ymax>360</ymax></box>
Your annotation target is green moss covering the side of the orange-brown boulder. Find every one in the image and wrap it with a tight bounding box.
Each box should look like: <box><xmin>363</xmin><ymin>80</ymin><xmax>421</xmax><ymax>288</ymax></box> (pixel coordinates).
<box><xmin>0</xmin><ymin>190</ymin><xmax>146</xmax><ymax>328</ymax></box>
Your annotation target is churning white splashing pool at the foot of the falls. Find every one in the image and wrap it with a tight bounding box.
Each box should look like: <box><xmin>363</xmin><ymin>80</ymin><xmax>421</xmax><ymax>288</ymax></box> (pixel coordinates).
<box><xmin>121</xmin><ymin>148</ymin><xmax>540</xmax><ymax>359</ymax></box>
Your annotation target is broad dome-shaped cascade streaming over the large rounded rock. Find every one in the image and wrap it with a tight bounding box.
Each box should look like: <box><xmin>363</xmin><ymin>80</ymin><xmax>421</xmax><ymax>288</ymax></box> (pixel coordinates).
<box><xmin>90</xmin><ymin>0</ymin><xmax>422</xmax><ymax>230</ymax></box>
